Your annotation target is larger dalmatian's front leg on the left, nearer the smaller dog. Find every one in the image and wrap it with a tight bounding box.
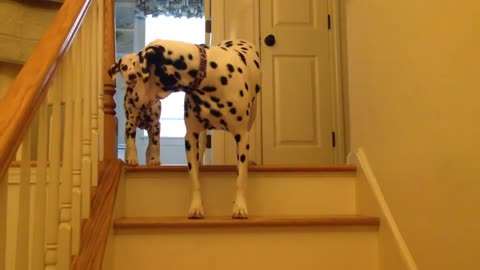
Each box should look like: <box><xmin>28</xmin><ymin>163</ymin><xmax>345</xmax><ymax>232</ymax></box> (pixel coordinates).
<box><xmin>185</xmin><ymin>130</ymin><xmax>203</xmax><ymax>219</ymax></box>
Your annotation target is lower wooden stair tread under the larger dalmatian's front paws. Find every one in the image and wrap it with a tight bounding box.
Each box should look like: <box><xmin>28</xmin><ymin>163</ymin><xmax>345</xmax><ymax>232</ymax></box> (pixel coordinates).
<box><xmin>113</xmin><ymin>215</ymin><xmax>380</xmax><ymax>230</ymax></box>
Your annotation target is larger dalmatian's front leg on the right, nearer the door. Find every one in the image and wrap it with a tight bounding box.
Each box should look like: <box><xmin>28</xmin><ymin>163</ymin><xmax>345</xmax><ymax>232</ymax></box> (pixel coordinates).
<box><xmin>232</xmin><ymin>132</ymin><xmax>250</xmax><ymax>218</ymax></box>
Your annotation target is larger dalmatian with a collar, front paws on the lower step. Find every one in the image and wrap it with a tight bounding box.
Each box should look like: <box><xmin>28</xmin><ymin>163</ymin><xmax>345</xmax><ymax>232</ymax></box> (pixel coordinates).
<box><xmin>110</xmin><ymin>40</ymin><xmax>261</xmax><ymax>218</ymax></box>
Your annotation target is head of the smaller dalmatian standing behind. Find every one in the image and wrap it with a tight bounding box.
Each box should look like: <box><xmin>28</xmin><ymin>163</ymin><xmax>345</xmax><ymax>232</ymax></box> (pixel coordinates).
<box><xmin>108</xmin><ymin>53</ymin><xmax>143</xmax><ymax>88</ymax></box>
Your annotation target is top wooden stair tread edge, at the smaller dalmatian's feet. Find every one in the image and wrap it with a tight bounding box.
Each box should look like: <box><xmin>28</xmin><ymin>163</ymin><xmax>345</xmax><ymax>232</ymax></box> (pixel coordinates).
<box><xmin>126</xmin><ymin>165</ymin><xmax>356</xmax><ymax>172</ymax></box>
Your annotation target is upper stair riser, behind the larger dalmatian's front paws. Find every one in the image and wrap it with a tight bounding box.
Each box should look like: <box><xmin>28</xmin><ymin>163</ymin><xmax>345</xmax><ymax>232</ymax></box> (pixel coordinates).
<box><xmin>124</xmin><ymin>172</ymin><xmax>355</xmax><ymax>217</ymax></box>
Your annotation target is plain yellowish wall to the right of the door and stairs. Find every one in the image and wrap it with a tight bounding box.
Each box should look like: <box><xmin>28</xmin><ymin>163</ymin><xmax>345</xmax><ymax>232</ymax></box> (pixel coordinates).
<box><xmin>343</xmin><ymin>0</ymin><xmax>480</xmax><ymax>270</ymax></box>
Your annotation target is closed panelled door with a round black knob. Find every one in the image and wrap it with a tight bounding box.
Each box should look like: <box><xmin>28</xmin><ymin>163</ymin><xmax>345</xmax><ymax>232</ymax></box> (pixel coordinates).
<box><xmin>260</xmin><ymin>0</ymin><xmax>334</xmax><ymax>164</ymax></box>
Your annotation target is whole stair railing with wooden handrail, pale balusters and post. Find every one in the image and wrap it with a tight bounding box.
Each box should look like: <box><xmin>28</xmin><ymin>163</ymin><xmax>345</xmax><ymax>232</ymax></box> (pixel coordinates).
<box><xmin>0</xmin><ymin>0</ymin><xmax>116</xmax><ymax>270</ymax></box>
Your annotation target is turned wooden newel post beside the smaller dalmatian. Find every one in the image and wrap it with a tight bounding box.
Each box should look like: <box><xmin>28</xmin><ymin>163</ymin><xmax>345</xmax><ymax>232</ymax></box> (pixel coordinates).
<box><xmin>103</xmin><ymin>0</ymin><xmax>118</xmax><ymax>160</ymax></box>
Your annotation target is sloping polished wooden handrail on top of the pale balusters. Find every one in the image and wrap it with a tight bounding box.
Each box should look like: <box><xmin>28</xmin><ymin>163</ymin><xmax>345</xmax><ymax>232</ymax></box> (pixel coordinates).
<box><xmin>0</xmin><ymin>0</ymin><xmax>93</xmax><ymax>179</ymax></box>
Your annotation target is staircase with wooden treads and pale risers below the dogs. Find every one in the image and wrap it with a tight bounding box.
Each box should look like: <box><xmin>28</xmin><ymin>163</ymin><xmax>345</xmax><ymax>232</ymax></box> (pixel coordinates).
<box><xmin>103</xmin><ymin>166</ymin><xmax>380</xmax><ymax>270</ymax></box>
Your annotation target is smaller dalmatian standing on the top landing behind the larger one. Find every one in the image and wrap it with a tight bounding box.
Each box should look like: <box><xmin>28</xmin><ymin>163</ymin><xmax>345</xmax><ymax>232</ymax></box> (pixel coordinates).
<box><xmin>108</xmin><ymin>54</ymin><xmax>162</xmax><ymax>165</ymax></box>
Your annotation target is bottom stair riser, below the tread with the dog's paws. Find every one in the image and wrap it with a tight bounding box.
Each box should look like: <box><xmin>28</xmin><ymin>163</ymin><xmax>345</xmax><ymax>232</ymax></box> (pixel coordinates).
<box><xmin>112</xmin><ymin>228</ymin><xmax>378</xmax><ymax>270</ymax></box>
